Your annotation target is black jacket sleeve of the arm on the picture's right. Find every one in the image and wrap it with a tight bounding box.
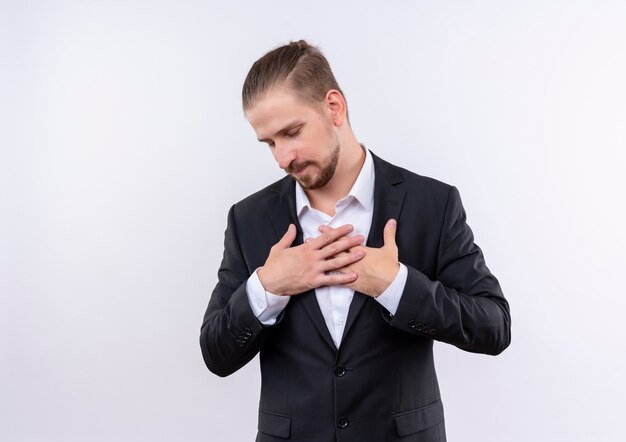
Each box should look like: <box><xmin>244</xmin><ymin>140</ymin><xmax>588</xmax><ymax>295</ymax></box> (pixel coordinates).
<box><xmin>390</xmin><ymin>187</ymin><xmax>511</xmax><ymax>355</ymax></box>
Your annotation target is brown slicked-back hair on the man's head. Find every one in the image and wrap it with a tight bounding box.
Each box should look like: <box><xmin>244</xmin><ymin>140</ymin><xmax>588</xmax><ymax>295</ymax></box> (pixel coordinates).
<box><xmin>241</xmin><ymin>40</ymin><xmax>347</xmax><ymax>112</ymax></box>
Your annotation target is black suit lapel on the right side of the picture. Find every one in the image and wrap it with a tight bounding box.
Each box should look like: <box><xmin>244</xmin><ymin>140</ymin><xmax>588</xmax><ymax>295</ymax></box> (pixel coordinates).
<box><xmin>341</xmin><ymin>151</ymin><xmax>406</xmax><ymax>343</ymax></box>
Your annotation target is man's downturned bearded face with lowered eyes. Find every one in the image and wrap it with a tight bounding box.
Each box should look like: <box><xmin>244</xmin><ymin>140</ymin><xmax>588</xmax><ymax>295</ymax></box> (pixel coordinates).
<box><xmin>246</xmin><ymin>87</ymin><xmax>340</xmax><ymax>190</ymax></box>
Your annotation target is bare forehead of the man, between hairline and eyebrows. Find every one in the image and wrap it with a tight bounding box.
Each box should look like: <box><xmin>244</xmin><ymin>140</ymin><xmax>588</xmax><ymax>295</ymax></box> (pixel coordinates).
<box><xmin>246</xmin><ymin>87</ymin><xmax>321</xmax><ymax>138</ymax></box>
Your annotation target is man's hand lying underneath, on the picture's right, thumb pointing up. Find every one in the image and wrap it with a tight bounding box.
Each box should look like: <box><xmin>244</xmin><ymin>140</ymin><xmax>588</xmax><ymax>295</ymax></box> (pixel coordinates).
<box><xmin>319</xmin><ymin>219</ymin><xmax>400</xmax><ymax>298</ymax></box>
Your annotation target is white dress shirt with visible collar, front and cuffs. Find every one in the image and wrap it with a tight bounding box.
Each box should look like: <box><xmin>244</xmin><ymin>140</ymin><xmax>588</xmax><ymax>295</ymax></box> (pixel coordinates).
<box><xmin>246</xmin><ymin>147</ymin><xmax>407</xmax><ymax>348</ymax></box>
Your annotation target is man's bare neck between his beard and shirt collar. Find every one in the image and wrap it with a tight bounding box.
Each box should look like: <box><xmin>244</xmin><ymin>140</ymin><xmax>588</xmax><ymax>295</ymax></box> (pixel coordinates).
<box><xmin>305</xmin><ymin>136</ymin><xmax>365</xmax><ymax>216</ymax></box>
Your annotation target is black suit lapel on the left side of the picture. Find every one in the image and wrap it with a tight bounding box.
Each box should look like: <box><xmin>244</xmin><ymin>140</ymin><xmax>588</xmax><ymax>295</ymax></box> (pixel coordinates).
<box><xmin>267</xmin><ymin>177</ymin><xmax>337</xmax><ymax>350</ymax></box>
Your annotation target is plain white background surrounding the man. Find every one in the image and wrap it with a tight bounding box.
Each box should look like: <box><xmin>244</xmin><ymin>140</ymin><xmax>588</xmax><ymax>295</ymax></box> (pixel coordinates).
<box><xmin>0</xmin><ymin>0</ymin><xmax>626</xmax><ymax>442</ymax></box>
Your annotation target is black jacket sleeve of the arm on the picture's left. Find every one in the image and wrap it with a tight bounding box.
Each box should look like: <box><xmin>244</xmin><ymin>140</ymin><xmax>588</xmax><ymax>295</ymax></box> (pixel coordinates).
<box><xmin>200</xmin><ymin>206</ymin><xmax>282</xmax><ymax>376</ymax></box>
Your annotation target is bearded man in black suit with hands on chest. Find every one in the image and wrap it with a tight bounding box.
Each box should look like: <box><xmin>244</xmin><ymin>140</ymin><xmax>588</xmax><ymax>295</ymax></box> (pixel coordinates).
<box><xmin>200</xmin><ymin>41</ymin><xmax>510</xmax><ymax>442</ymax></box>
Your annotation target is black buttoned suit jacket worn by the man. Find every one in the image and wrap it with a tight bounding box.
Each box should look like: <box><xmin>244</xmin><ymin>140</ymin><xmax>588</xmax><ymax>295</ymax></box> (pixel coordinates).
<box><xmin>200</xmin><ymin>155</ymin><xmax>510</xmax><ymax>442</ymax></box>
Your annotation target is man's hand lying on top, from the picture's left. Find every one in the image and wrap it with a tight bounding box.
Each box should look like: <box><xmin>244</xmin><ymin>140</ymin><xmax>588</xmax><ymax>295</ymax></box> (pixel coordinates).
<box><xmin>257</xmin><ymin>224</ymin><xmax>365</xmax><ymax>296</ymax></box>
